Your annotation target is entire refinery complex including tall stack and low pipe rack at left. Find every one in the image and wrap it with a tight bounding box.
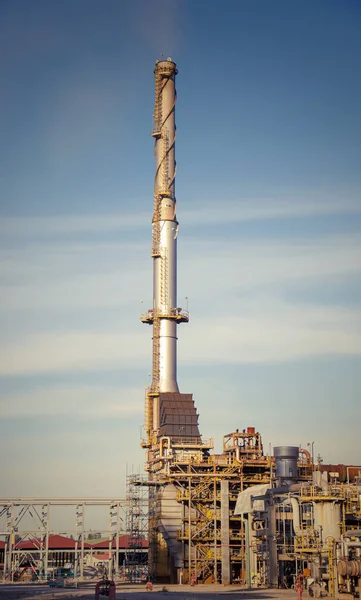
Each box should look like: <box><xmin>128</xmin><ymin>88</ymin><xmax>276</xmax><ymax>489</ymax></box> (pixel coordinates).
<box><xmin>0</xmin><ymin>59</ymin><xmax>361</xmax><ymax>599</ymax></box>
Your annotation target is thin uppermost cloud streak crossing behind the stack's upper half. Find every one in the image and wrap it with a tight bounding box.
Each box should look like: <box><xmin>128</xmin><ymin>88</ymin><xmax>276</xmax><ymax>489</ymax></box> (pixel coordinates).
<box><xmin>0</xmin><ymin>193</ymin><xmax>361</xmax><ymax>238</ymax></box>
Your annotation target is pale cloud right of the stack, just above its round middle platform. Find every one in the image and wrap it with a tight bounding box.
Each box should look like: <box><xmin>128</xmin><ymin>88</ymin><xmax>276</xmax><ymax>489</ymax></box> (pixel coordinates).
<box><xmin>180</xmin><ymin>234</ymin><xmax>361</xmax><ymax>300</ymax></box>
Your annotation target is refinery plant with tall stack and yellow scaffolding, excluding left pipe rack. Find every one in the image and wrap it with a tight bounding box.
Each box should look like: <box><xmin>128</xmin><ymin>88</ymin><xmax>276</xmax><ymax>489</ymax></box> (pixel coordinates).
<box><xmin>141</xmin><ymin>58</ymin><xmax>361</xmax><ymax>596</ymax></box>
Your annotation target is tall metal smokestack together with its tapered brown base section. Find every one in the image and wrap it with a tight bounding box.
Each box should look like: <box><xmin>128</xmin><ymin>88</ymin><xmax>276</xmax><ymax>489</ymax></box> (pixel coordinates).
<box><xmin>142</xmin><ymin>58</ymin><xmax>199</xmax><ymax>447</ymax></box>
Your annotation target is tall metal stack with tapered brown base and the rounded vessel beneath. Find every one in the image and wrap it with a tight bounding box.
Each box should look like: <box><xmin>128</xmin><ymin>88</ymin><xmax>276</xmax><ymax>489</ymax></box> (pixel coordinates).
<box><xmin>141</xmin><ymin>58</ymin><xmax>204</xmax><ymax>579</ymax></box>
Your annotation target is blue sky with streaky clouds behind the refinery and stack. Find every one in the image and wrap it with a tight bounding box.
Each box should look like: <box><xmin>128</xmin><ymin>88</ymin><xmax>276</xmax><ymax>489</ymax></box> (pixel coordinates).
<box><xmin>0</xmin><ymin>0</ymin><xmax>361</xmax><ymax>496</ymax></box>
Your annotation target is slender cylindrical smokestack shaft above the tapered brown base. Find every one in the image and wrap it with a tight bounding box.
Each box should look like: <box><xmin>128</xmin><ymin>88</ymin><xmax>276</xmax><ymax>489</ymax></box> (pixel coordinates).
<box><xmin>143</xmin><ymin>58</ymin><xmax>188</xmax><ymax>392</ymax></box>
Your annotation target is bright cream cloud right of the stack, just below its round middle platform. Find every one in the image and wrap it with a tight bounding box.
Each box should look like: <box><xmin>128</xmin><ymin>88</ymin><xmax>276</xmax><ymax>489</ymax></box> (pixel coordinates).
<box><xmin>183</xmin><ymin>299</ymin><xmax>361</xmax><ymax>364</ymax></box>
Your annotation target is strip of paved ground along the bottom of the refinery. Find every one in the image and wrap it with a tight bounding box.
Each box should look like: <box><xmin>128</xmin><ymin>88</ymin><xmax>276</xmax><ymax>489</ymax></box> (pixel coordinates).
<box><xmin>0</xmin><ymin>583</ymin><xmax>300</xmax><ymax>600</ymax></box>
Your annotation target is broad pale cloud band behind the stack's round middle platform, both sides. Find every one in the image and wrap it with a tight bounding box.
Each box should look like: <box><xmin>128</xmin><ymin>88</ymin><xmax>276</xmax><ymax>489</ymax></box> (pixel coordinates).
<box><xmin>0</xmin><ymin>225</ymin><xmax>361</xmax><ymax>376</ymax></box>
